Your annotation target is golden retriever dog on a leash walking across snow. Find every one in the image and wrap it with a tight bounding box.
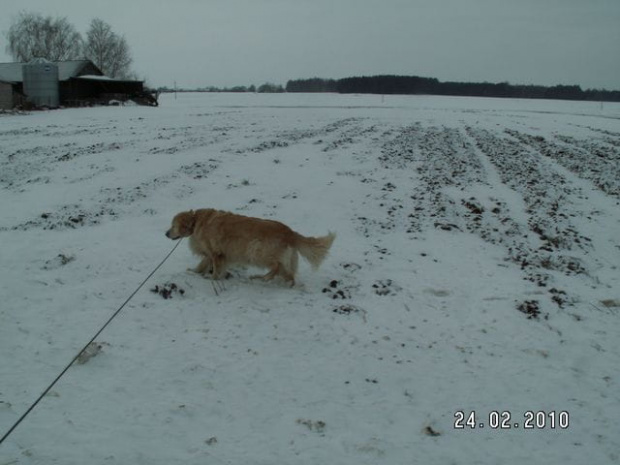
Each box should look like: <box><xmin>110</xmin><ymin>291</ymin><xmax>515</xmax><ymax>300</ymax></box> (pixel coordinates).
<box><xmin>166</xmin><ymin>208</ymin><xmax>336</xmax><ymax>286</ymax></box>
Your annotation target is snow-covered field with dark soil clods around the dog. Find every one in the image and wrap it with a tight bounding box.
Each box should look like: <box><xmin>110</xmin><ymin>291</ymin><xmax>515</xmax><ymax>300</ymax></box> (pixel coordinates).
<box><xmin>0</xmin><ymin>94</ymin><xmax>620</xmax><ymax>465</ymax></box>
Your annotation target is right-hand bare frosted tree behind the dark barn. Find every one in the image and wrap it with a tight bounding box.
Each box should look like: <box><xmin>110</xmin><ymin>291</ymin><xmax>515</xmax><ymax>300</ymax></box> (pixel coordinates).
<box><xmin>84</xmin><ymin>18</ymin><xmax>132</xmax><ymax>78</ymax></box>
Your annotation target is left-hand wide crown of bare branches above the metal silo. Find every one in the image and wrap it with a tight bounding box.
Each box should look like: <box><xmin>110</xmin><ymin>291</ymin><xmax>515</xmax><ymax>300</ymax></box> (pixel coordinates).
<box><xmin>6</xmin><ymin>12</ymin><xmax>82</xmax><ymax>61</ymax></box>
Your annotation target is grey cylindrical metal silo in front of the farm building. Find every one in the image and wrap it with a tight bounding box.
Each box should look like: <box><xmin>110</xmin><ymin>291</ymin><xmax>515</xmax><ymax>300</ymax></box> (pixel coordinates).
<box><xmin>22</xmin><ymin>58</ymin><xmax>60</xmax><ymax>108</ymax></box>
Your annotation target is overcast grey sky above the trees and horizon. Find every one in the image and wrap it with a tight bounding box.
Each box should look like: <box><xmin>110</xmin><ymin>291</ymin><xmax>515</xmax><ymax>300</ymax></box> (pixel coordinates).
<box><xmin>0</xmin><ymin>0</ymin><xmax>620</xmax><ymax>90</ymax></box>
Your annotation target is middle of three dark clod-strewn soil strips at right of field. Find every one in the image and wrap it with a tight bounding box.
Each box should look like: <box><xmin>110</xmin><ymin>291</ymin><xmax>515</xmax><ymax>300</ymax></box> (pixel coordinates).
<box><xmin>467</xmin><ymin>128</ymin><xmax>595</xmax><ymax>306</ymax></box>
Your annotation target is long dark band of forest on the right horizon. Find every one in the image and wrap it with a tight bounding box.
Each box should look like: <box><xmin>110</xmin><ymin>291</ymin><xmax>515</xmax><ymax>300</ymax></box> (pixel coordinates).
<box><xmin>286</xmin><ymin>75</ymin><xmax>620</xmax><ymax>102</ymax></box>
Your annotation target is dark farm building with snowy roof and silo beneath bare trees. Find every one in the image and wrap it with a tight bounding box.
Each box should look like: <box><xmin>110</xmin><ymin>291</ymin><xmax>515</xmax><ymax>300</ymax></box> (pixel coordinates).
<box><xmin>0</xmin><ymin>58</ymin><xmax>157</xmax><ymax>109</ymax></box>
